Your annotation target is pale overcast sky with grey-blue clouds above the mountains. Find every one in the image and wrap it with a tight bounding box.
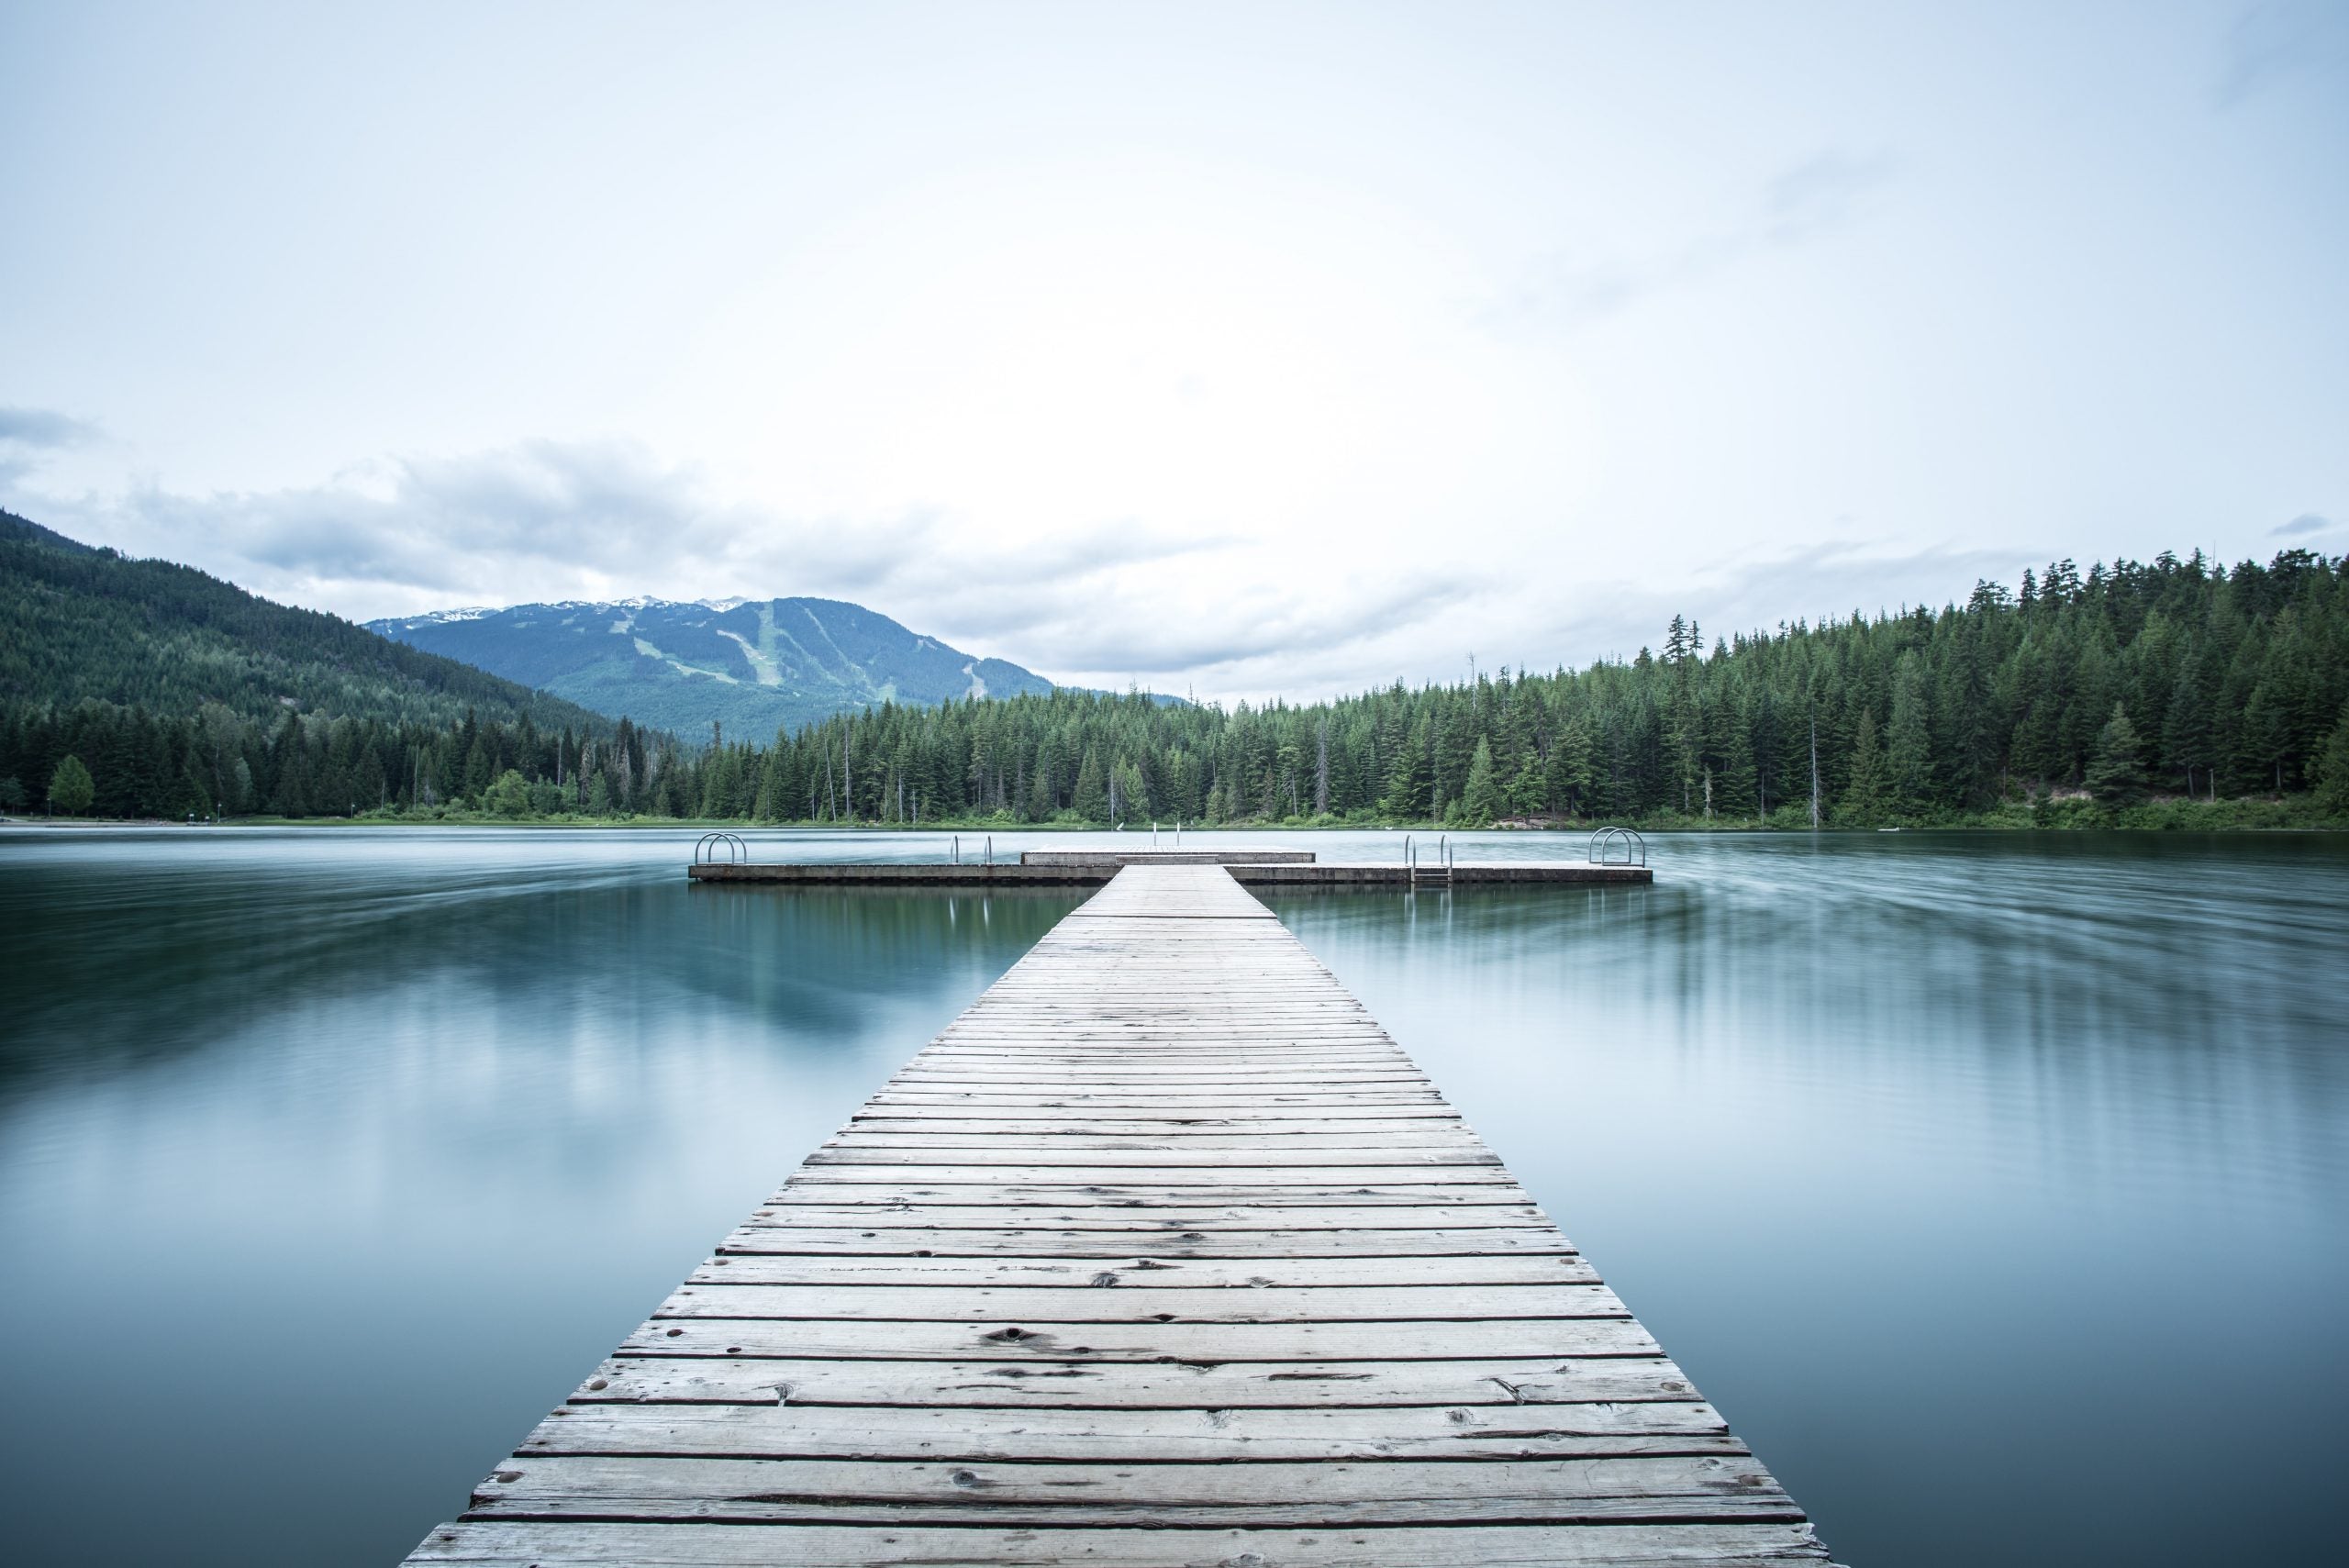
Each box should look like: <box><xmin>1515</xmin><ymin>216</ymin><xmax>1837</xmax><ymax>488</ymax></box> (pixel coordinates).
<box><xmin>0</xmin><ymin>0</ymin><xmax>2349</xmax><ymax>699</ymax></box>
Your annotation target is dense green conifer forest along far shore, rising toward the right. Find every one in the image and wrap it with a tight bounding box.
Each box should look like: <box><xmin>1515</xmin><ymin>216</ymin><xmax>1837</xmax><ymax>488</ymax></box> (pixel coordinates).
<box><xmin>0</xmin><ymin>551</ymin><xmax>2349</xmax><ymax>827</ymax></box>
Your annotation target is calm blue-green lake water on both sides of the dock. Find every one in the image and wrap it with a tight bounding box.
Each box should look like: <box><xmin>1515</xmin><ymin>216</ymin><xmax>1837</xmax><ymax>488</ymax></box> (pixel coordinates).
<box><xmin>0</xmin><ymin>828</ymin><xmax>2349</xmax><ymax>1568</ymax></box>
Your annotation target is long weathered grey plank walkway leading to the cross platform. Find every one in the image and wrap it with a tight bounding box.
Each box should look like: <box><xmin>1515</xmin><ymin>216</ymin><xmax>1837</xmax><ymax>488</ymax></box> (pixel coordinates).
<box><xmin>408</xmin><ymin>866</ymin><xmax>1825</xmax><ymax>1568</ymax></box>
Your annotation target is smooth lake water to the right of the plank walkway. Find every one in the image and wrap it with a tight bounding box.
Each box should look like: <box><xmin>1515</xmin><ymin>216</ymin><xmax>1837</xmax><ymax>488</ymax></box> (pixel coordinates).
<box><xmin>1278</xmin><ymin>836</ymin><xmax>2349</xmax><ymax>1563</ymax></box>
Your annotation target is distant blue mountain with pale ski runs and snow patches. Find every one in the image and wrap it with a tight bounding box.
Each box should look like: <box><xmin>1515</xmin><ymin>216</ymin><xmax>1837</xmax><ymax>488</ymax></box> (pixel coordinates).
<box><xmin>366</xmin><ymin>598</ymin><xmax>1052</xmax><ymax>740</ymax></box>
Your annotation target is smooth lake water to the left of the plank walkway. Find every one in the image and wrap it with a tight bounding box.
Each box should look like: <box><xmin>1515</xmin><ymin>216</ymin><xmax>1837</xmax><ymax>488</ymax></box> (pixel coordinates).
<box><xmin>0</xmin><ymin>833</ymin><xmax>1074</xmax><ymax>1563</ymax></box>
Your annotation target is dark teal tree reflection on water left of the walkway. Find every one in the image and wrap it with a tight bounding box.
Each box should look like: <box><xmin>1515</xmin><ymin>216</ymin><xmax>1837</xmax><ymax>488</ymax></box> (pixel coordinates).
<box><xmin>0</xmin><ymin>866</ymin><xmax>1075</xmax><ymax>1089</ymax></box>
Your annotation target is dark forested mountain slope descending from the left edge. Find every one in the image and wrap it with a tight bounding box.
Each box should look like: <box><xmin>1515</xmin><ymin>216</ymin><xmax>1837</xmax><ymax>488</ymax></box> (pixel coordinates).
<box><xmin>0</xmin><ymin>512</ymin><xmax>611</xmax><ymax>735</ymax></box>
